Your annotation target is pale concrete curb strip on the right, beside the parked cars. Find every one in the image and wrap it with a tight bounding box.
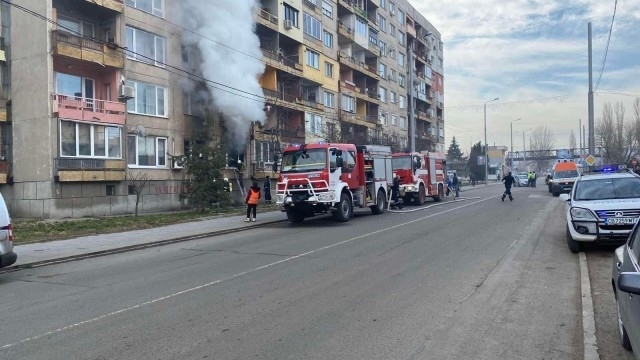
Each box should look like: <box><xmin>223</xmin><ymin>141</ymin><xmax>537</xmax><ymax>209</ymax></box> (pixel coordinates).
<box><xmin>579</xmin><ymin>252</ymin><xmax>600</xmax><ymax>360</ymax></box>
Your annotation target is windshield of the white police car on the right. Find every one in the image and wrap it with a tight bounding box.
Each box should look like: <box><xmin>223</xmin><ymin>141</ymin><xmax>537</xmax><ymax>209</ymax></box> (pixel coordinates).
<box><xmin>573</xmin><ymin>177</ymin><xmax>640</xmax><ymax>200</ymax></box>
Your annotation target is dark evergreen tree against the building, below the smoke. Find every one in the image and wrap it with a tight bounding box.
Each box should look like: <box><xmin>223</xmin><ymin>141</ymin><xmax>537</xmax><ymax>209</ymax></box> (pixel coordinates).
<box><xmin>179</xmin><ymin>117</ymin><xmax>229</xmax><ymax>211</ymax></box>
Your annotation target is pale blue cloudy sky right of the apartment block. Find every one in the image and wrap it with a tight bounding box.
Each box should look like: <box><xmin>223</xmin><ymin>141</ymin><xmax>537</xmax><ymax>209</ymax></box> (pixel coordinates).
<box><xmin>409</xmin><ymin>0</ymin><xmax>640</xmax><ymax>153</ymax></box>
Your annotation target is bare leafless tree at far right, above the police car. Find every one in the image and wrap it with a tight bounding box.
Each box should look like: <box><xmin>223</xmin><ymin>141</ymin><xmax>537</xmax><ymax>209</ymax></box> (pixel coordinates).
<box><xmin>596</xmin><ymin>102</ymin><xmax>638</xmax><ymax>164</ymax></box>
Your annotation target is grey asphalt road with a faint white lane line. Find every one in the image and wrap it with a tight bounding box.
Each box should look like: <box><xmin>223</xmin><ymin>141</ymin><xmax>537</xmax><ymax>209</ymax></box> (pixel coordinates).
<box><xmin>0</xmin><ymin>186</ymin><xmax>628</xmax><ymax>360</ymax></box>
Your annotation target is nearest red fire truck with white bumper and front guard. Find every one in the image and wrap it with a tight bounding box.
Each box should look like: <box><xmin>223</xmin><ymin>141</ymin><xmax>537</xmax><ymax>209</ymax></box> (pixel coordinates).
<box><xmin>276</xmin><ymin>143</ymin><xmax>393</xmax><ymax>223</ymax></box>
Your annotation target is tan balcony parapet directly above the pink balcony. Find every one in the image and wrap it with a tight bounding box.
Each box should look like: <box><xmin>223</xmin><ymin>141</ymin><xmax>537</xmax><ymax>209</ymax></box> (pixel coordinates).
<box><xmin>51</xmin><ymin>30</ymin><xmax>124</xmax><ymax>69</ymax></box>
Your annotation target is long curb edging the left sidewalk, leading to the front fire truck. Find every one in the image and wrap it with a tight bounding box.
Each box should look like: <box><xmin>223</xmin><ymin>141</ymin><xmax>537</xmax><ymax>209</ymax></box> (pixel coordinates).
<box><xmin>0</xmin><ymin>219</ymin><xmax>288</xmax><ymax>274</ymax></box>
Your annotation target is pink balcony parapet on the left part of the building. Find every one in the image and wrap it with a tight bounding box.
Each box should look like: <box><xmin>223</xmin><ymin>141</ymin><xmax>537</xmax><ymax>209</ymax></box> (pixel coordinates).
<box><xmin>53</xmin><ymin>94</ymin><xmax>127</xmax><ymax>125</ymax></box>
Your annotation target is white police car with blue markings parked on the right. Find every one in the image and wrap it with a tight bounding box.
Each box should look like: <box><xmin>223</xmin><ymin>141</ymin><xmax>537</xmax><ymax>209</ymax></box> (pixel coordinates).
<box><xmin>560</xmin><ymin>166</ymin><xmax>640</xmax><ymax>253</ymax></box>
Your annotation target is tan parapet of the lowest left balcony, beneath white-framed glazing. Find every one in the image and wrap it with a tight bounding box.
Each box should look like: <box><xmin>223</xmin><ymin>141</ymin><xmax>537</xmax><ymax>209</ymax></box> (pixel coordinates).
<box><xmin>53</xmin><ymin>157</ymin><xmax>127</xmax><ymax>182</ymax></box>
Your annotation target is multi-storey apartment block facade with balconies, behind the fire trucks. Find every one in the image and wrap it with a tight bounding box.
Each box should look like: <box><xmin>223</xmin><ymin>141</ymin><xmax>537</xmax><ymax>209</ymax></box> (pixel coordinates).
<box><xmin>0</xmin><ymin>0</ymin><xmax>444</xmax><ymax>218</ymax></box>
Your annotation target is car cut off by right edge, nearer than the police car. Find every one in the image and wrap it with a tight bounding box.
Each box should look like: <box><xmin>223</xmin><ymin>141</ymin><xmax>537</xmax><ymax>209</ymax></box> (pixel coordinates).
<box><xmin>611</xmin><ymin>222</ymin><xmax>640</xmax><ymax>360</ymax></box>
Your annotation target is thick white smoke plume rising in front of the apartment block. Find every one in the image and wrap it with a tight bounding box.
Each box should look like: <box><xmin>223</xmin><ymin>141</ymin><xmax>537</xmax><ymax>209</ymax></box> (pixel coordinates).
<box><xmin>180</xmin><ymin>0</ymin><xmax>265</xmax><ymax>150</ymax></box>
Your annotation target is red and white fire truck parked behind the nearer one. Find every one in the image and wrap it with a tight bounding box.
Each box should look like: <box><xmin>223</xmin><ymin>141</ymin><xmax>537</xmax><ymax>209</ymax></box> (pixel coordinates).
<box><xmin>392</xmin><ymin>151</ymin><xmax>447</xmax><ymax>205</ymax></box>
